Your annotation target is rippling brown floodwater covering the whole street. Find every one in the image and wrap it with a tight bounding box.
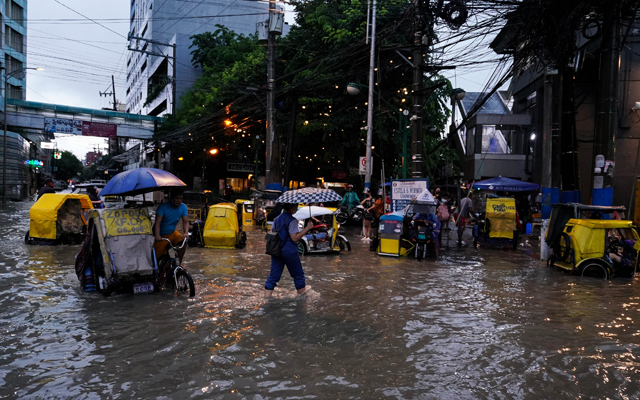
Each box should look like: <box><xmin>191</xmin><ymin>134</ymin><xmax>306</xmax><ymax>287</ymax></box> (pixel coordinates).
<box><xmin>0</xmin><ymin>203</ymin><xmax>640</xmax><ymax>399</ymax></box>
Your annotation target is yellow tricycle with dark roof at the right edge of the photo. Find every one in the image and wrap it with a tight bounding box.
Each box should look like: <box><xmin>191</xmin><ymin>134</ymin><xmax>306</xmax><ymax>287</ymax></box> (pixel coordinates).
<box><xmin>549</xmin><ymin>219</ymin><xmax>640</xmax><ymax>280</ymax></box>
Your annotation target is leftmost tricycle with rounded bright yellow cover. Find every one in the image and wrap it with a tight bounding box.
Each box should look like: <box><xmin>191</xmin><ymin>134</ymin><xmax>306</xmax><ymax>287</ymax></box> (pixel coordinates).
<box><xmin>24</xmin><ymin>193</ymin><xmax>93</xmax><ymax>245</ymax></box>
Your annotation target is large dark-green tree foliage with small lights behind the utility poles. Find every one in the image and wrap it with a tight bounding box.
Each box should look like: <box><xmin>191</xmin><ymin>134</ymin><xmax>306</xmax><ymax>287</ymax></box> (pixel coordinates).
<box><xmin>165</xmin><ymin>0</ymin><xmax>455</xmax><ymax>183</ymax></box>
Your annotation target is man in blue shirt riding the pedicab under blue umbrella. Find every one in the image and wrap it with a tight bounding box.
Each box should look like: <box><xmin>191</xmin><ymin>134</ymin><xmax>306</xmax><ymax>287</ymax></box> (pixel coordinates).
<box><xmin>153</xmin><ymin>189</ymin><xmax>189</xmax><ymax>265</ymax></box>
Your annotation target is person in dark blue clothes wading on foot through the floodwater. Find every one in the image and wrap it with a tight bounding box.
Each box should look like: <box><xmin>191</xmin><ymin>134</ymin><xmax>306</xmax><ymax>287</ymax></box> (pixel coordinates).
<box><xmin>264</xmin><ymin>203</ymin><xmax>313</xmax><ymax>298</ymax></box>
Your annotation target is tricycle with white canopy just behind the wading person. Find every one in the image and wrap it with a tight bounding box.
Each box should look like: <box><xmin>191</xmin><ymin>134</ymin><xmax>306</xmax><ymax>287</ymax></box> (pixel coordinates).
<box><xmin>293</xmin><ymin>206</ymin><xmax>351</xmax><ymax>255</ymax></box>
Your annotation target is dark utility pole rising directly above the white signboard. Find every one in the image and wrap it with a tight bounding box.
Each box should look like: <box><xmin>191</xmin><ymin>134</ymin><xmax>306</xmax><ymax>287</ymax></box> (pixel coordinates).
<box><xmin>411</xmin><ymin>0</ymin><xmax>424</xmax><ymax>179</ymax></box>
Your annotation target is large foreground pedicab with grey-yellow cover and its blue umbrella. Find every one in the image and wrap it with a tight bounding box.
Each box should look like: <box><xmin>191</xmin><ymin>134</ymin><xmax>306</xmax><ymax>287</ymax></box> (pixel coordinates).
<box><xmin>75</xmin><ymin>168</ymin><xmax>195</xmax><ymax>296</ymax></box>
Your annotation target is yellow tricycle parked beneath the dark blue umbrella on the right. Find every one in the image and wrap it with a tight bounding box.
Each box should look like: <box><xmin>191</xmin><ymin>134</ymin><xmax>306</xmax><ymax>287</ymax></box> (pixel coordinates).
<box><xmin>473</xmin><ymin>197</ymin><xmax>520</xmax><ymax>249</ymax></box>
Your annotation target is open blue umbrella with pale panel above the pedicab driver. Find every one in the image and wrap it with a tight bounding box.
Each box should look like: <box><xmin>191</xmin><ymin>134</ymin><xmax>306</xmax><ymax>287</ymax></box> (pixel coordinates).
<box><xmin>100</xmin><ymin>168</ymin><xmax>187</xmax><ymax>196</ymax></box>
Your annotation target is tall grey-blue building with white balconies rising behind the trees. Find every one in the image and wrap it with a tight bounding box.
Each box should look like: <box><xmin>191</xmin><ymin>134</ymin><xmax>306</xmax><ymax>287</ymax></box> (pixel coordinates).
<box><xmin>126</xmin><ymin>0</ymin><xmax>269</xmax><ymax>116</ymax></box>
